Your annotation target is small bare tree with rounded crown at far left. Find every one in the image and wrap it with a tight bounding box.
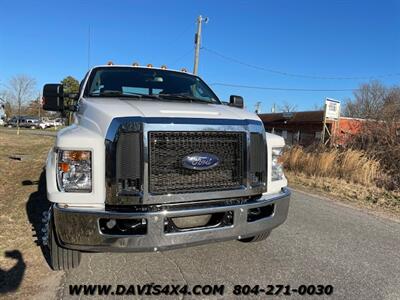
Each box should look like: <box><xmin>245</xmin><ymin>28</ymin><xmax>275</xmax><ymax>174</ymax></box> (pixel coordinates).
<box><xmin>7</xmin><ymin>75</ymin><xmax>36</xmax><ymax>134</ymax></box>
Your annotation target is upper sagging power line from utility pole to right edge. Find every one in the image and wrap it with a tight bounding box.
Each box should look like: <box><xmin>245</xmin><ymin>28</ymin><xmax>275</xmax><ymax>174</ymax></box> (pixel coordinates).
<box><xmin>202</xmin><ymin>46</ymin><xmax>400</xmax><ymax>80</ymax></box>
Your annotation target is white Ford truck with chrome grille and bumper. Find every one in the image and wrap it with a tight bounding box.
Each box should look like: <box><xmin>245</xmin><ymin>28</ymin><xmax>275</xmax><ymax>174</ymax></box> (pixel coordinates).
<box><xmin>43</xmin><ymin>65</ymin><xmax>290</xmax><ymax>270</ymax></box>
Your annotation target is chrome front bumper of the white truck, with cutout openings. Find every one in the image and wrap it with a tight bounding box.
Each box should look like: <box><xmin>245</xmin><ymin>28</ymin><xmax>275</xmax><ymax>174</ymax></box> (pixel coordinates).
<box><xmin>53</xmin><ymin>188</ymin><xmax>290</xmax><ymax>252</ymax></box>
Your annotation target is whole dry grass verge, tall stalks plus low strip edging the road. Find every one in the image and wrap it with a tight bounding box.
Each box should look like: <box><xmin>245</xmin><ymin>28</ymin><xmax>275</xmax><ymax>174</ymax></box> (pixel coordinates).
<box><xmin>283</xmin><ymin>147</ymin><xmax>400</xmax><ymax>216</ymax></box>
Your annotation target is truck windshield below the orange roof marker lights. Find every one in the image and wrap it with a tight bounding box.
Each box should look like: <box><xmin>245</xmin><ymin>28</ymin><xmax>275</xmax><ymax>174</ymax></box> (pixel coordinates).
<box><xmin>85</xmin><ymin>67</ymin><xmax>221</xmax><ymax>104</ymax></box>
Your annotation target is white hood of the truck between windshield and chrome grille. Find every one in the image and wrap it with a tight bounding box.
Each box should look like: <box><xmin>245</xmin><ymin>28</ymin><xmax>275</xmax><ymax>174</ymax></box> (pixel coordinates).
<box><xmin>76</xmin><ymin>98</ymin><xmax>261</xmax><ymax>136</ymax></box>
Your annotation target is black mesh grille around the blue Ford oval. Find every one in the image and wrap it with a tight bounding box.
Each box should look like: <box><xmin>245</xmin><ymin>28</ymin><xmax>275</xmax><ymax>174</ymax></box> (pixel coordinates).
<box><xmin>148</xmin><ymin>131</ymin><xmax>246</xmax><ymax>195</ymax></box>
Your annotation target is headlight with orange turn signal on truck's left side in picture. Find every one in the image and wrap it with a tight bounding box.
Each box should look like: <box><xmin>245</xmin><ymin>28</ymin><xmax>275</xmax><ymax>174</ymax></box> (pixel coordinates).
<box><xmin>57</xmin><ymin>150</ymin><xmax>92</xmax><ymax>193</ymax></box>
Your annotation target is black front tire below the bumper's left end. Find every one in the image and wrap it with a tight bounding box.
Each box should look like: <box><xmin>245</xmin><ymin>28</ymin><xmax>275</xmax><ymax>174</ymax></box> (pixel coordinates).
<box><xmin>49</xmin><ymin>222</ymin><xmax>82</xmax><ymax>271</ymax></box>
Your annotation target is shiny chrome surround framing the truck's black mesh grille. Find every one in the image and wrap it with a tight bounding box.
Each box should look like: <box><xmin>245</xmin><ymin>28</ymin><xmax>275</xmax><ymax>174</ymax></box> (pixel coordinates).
<box><xmin>105</xmin><ymin>117</ymin><xmax>266</xmax><ymax>205</ymax></box>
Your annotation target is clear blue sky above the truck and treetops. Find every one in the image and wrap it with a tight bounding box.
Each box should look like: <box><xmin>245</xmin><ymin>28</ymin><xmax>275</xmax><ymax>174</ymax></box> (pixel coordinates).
<box><xmin>0</xmin><ymin>0</ymin><xmax>400</xmax><ymax>112</ymax></box>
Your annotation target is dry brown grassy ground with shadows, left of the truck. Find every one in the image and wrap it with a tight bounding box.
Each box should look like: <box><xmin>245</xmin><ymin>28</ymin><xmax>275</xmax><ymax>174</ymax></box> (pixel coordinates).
<box><xmin>0</xmin><ymin>130</ymin><xmax>62</xmax><ymax>299</ymax></box>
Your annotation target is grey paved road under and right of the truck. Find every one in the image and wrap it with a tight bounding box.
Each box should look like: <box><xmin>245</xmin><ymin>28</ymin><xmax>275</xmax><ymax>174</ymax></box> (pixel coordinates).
<box><xmin>58</xmin><ymin>192</ymin><xmax>400</xmax><ymax>299</ymax></box>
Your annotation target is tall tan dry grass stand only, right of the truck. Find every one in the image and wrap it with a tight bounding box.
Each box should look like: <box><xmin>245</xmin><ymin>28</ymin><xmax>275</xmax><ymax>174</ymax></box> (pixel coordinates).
<box><xmin>283</xmin><ymin>147</ymin><xmax>383</xmax><ymax>185</ymax></box>
